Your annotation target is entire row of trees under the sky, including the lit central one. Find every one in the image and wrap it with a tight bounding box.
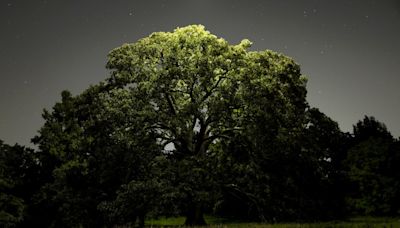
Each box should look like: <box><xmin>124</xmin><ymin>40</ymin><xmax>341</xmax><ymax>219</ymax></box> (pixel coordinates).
<box><xmin>0</xmin><ymin>26</ymin><xmax>400</xmax><ymax>227</ymax></box>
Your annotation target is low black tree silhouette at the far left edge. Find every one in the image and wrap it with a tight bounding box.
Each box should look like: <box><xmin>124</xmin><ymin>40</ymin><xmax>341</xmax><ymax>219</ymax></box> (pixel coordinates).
<box><xmin>0</xmin><ymin>140</ymin><xmax>40</xmax><ymax>227</ymax></box>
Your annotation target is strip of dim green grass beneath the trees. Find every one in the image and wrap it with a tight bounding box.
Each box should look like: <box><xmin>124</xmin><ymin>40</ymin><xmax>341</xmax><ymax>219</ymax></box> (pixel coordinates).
<box><xmin>146</xmin><ymin>216</ymin><xmax>400</xmax><ymax>228</ymax></box>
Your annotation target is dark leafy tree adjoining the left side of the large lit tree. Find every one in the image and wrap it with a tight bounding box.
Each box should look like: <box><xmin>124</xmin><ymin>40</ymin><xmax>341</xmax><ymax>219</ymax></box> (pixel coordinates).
<box><xmin>33</xmin><ymin>86</ymin><xmax>159</xmax><ymax>227</ymax></box>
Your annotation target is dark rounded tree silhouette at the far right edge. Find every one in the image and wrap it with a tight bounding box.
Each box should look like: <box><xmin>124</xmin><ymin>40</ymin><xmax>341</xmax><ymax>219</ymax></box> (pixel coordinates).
<box><xmin>345</xmin><ymin>116</ymin><xmax>400</xmax><ymax>215</ymax></box>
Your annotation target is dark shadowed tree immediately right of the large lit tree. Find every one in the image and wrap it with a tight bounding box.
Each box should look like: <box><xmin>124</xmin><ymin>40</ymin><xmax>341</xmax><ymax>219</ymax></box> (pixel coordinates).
<box><xmin>299</xmin><ymin>108</ymin><xmax>349</xmax><ymax>220</ymax></box>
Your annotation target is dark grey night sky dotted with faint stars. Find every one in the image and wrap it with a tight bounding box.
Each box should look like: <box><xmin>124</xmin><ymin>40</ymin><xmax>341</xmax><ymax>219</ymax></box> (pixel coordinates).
<box><xmin>0</xmin><ymin>0</ymin><xmax>400</xmax><ymax>145</ymax></box>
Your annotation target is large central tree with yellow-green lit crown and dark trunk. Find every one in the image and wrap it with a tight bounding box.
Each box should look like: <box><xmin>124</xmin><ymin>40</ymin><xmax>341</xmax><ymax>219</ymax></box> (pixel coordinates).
<box><xmin>105</xmin><ymin>26</ymin><xmax>307</xmax><ymax>225</ymax></box>
